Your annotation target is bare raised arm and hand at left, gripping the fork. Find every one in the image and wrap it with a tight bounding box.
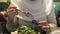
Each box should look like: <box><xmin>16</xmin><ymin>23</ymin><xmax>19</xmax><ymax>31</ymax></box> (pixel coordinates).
<box><xmin>6</xmin><ymin>8</ymin><xmax>18</xmax><ymax>31</ymax></box>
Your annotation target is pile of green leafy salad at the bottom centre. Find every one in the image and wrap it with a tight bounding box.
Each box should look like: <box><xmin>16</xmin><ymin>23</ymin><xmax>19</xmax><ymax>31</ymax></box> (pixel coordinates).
<box><xmin>16</xmin><ymin>25</ymin><xmax>37</xmax><ymax>34</ymax></box>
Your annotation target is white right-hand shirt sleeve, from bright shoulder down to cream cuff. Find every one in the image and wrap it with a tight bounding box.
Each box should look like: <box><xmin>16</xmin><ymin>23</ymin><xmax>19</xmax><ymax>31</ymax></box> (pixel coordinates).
<box><xmin>47</xmin><ymin>1</ymin><xmax>57</xmax><ymax>28</ymax></box>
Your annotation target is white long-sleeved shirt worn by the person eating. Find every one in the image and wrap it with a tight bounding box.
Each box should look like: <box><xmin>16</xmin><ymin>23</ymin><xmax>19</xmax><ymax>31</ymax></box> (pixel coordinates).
<box><xmin>12</xmin><ymin>0</ymin><xmax>57</xmax><ymax>27</ymax></box>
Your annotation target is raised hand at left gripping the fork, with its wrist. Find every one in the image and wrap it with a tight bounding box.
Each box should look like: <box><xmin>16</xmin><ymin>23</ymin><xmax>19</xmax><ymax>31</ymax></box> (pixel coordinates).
<box><xmin>7</xmin><ymin>7</ymin><xmax>18</xmax><ymax>21</ymax></box>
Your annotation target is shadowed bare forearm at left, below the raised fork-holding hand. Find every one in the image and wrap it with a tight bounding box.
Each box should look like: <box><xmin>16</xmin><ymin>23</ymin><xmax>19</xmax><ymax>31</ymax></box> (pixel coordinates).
<box><xmin>6</xmin><ymin>17</ymin><xmax>16</xmax><ymax>31</ymax></box>
